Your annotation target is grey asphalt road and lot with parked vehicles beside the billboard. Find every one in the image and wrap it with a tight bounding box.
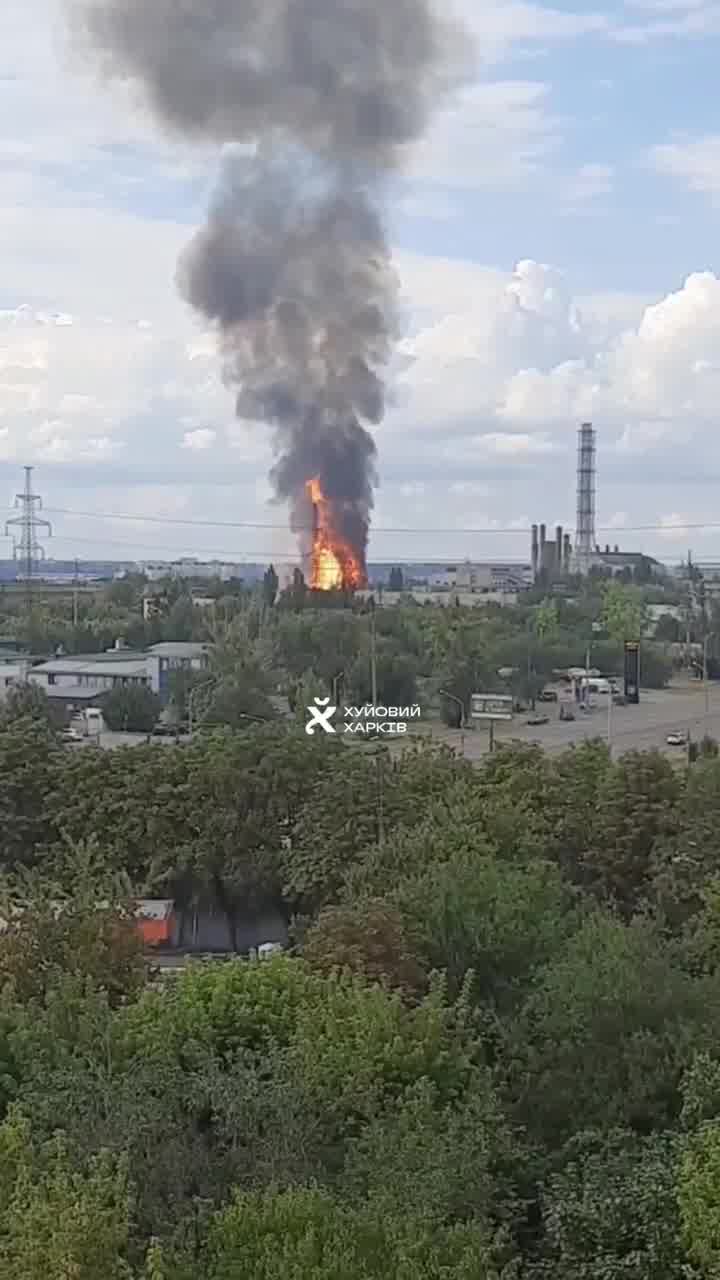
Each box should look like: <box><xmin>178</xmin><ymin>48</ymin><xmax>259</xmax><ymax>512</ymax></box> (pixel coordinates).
<box><xmin>447</xmin><ymin>685</ymin><xmax>720</xmax><ymax>760</ymax></box>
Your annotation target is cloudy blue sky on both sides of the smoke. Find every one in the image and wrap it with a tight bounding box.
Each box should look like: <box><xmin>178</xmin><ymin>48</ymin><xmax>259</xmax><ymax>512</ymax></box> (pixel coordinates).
<box><xmin>0</xmin><ymin>0</ymin><xmax>720</xmax><ymax>559</ymax></box>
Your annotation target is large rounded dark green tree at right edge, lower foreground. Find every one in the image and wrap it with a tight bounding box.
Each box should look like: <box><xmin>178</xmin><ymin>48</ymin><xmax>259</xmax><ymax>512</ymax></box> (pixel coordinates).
<box><xmin>506</xmin><ymin>914</ymin><xmax>717</xmax><ymax>1144</ymax></box>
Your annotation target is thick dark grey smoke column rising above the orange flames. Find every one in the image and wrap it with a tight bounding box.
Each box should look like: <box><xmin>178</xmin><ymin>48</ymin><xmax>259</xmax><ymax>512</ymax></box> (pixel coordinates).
<box><xmin>68</xmin><ymin>0</ymin><xmax>468</xmax><ymax>581</ymax></box>
